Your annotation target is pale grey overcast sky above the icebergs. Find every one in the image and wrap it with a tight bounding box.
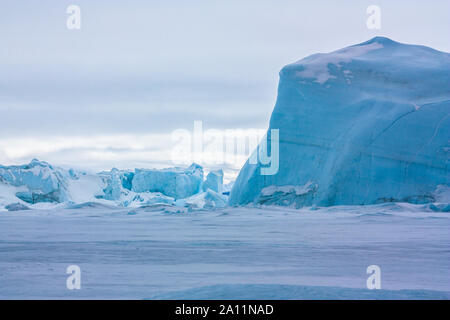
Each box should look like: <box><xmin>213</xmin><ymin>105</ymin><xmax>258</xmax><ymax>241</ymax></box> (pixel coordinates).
<box><xmin>0</xmin><ymin>0</ymin><xmax>450</xmax><ymax>176</ymax></box>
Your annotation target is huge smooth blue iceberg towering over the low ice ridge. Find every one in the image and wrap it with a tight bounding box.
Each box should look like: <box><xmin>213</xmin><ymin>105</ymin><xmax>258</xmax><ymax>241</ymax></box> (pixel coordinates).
<box><xmin>230</xmin><ymin>37</ymin><xmax>450</xmax><ymax>207</ymax></box>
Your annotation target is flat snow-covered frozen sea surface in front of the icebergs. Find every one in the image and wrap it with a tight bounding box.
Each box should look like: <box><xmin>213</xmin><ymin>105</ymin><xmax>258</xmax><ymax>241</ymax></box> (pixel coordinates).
<box><xmin>0</xmin><ymin>203</ymin><xmax>450</xmax><ymax>299</ymax></box>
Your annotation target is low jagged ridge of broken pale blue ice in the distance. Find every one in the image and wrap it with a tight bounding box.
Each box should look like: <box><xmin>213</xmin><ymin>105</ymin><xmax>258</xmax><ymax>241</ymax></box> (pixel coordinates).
<box><xmin>0</xmin><ymin>159</ymin><xmax>214</xmax><ymax>211</ymax></box>
